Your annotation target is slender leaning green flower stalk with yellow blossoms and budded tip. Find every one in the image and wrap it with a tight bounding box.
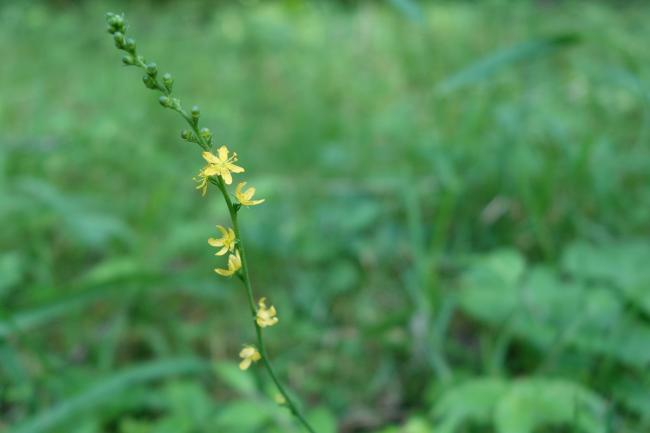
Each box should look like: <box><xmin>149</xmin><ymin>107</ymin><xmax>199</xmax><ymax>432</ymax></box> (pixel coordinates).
<box><xmin>106</xmin><ymin>13</ymin><xmax>315</xmax><ymax>433</ymax></box>
